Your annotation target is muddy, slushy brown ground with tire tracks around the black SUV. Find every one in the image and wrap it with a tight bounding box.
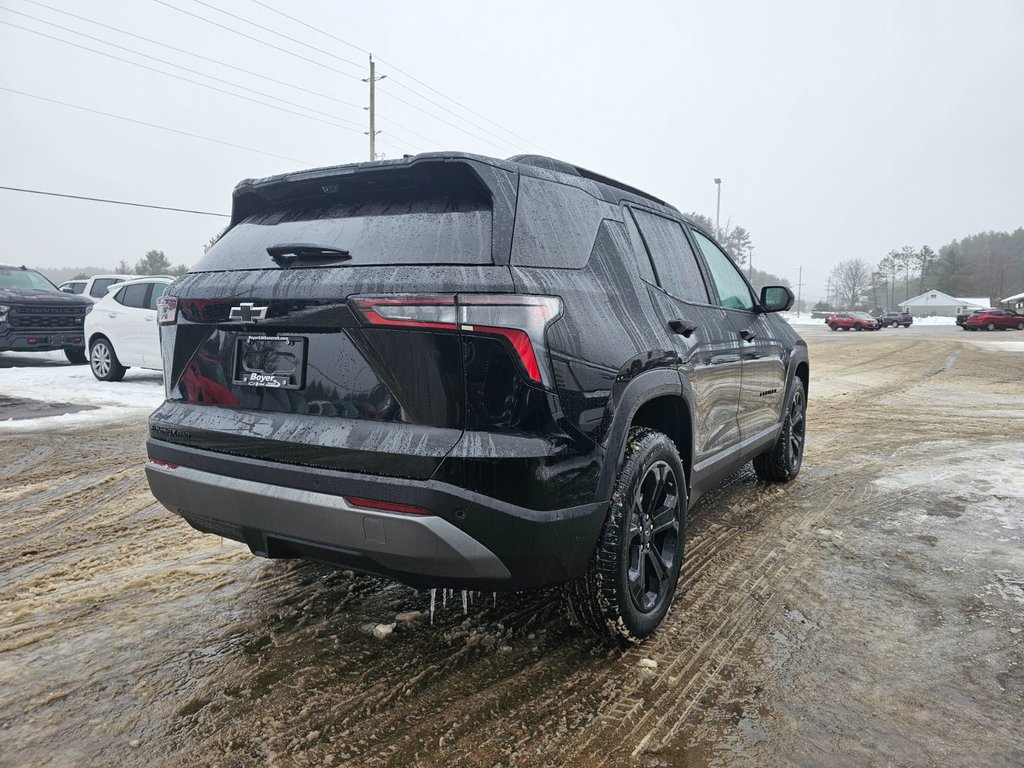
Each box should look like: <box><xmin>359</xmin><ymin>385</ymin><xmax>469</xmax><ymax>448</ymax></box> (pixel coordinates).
<box><xmin>0</xmin><ymin>328</ymin><xmax>1024</xmax><ymax>767</ymax></box>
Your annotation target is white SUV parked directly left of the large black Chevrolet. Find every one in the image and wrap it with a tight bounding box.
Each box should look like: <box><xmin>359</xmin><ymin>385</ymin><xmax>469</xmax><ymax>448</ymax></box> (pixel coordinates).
<box><xmin>85</xmin><ymin>276</ymin><xmax>174</xmax><ymax>381</ymax></box>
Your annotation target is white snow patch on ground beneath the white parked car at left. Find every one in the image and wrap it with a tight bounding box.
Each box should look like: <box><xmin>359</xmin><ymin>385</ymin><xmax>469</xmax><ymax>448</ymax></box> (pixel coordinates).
<box><xmin>0</xmin><ymin>352</ymin><xmax>164</xmax><ymax>430</ymax></box>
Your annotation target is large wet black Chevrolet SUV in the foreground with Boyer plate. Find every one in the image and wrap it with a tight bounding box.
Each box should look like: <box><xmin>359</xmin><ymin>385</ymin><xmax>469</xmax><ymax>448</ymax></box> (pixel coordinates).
<box><xmin>146</xmin><ymin>153</ymin><xmax>809</xmax><ymax>640</ymax></box>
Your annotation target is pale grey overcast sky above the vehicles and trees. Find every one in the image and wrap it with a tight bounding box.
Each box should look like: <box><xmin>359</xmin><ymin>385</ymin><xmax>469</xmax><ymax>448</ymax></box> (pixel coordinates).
<box><xmin>0</xmin><ymin>0</ymin><xmax>1024</xmax><ymax>299</ymax></box>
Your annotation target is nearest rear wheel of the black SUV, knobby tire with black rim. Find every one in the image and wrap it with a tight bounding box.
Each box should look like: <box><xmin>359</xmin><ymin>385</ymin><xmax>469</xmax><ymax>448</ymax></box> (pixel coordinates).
<box><xmin>562</xmin><ymin>427</ymin><xmax>687</xmax><ymax>643</ymax></box>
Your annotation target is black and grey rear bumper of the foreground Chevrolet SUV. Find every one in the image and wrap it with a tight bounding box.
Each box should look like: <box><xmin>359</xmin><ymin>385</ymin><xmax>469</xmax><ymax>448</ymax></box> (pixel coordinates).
<box><xmin>146</xmin><ymin>438</ymin><xmax>606</xmax><ymax>590</ymax></box>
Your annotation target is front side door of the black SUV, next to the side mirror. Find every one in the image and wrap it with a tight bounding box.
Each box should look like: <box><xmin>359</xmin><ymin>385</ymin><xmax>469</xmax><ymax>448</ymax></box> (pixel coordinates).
<box><xmin>691</xmin><ymin>229</ymin><xmax>785</xmax><ymax>440</ymax></box>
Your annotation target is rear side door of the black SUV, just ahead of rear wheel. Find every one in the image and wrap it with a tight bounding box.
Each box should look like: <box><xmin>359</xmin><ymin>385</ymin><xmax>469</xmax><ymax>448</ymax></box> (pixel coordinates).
<box><xmin>631</xmin><ymin>208</ymin><xmax>740</xmax><ymax>464</ymax></box>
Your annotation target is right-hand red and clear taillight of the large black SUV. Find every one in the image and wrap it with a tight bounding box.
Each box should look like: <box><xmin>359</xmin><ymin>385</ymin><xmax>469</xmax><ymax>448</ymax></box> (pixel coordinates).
<box><xmin>352</xmin><ymin>294</ymin><xmax>562</xmax><ymax>387</ymax></box>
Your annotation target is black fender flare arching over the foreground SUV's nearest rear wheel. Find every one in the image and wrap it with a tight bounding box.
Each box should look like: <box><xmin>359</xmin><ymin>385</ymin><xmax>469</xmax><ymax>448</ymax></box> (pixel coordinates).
<box><xmin>595</xmin><ymin>368</ymin><xmax>693</xmax><ymax>502</ymax></box>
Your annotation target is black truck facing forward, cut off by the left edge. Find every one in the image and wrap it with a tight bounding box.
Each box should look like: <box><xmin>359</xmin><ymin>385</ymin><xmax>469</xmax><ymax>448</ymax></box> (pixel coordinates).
<box><xmin>0</xmin><ymin>264</ymin><xmax>92</xmax><ymax>366</ymax></box>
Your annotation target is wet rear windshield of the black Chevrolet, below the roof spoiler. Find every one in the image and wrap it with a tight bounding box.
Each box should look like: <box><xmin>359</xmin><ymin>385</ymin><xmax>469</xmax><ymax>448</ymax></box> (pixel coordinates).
<box><xmin>193</xmin><ymin>197</ymin><xmax>495</xmax><ymax>272</ymax></box>
